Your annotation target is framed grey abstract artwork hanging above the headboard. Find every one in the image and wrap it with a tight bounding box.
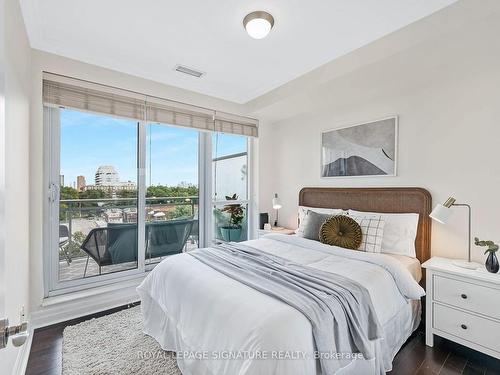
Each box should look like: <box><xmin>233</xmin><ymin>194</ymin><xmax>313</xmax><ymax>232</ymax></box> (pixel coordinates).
<box><xmin>321</xmin><ymin>116</ymin><xmax>398</xmax><ymax>177</ymax></box>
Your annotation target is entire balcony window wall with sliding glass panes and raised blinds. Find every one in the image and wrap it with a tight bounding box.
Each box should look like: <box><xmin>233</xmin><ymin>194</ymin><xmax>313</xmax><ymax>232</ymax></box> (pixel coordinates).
<box><xmin>43</xmin><ymin>74</ymin><xmax>257</xmax><ymax>296</ymax></box>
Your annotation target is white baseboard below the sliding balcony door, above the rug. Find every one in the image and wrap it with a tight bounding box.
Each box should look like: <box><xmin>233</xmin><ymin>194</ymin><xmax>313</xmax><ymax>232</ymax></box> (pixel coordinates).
<box><xmin>31</xmin><ymin>284</ymin><xmax>139</xmax><ymax>329</ymax></box>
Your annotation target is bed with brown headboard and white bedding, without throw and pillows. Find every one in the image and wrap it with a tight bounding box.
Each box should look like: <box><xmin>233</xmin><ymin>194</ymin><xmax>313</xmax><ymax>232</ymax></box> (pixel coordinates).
<box><xmin>138</xmin><ymin>188</ymin><xmax>431</xmax><ymax>375</ymax></box>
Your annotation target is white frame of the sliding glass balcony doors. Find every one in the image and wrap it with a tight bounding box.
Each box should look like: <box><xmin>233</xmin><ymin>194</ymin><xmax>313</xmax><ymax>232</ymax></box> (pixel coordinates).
<box><xmin>43</xmin><ymin>105</ymin><xmax>255</xmax><ymax>298</ymax></box>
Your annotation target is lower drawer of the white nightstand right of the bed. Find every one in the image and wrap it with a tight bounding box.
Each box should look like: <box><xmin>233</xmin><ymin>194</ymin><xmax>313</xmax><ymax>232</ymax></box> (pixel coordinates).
<box><xmin>433</xmin><ymin>303</ymin><xmax>500</xmax><ymax>352</ymax></box>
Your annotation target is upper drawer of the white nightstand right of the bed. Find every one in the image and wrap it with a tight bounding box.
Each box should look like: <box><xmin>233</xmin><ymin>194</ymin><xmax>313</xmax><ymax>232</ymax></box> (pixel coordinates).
<box><xmin>433</xmin><ymin>275</ymin><xmax>500</xmax><ymax>319</ymax></box>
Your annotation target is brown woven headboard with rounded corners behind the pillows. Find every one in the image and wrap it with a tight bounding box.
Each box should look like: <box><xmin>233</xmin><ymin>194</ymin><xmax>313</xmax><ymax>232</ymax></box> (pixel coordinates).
<box><xmin>299</xmin><ymin>187</ymin><xmax>432</xmax><ymax>263</ymax></box>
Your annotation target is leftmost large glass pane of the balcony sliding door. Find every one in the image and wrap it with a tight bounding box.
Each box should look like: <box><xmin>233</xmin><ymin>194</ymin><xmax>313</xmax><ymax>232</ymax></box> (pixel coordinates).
<box><xmin>51</xmin><ymin>109</ymin><xmax>139</xmax><ymax>284</ymax></box>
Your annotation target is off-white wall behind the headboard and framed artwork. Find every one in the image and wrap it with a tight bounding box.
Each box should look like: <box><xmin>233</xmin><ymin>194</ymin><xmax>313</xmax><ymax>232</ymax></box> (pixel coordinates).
<box><xmin>256</xmin><ymin>1</ymin><xmax>500</xmax><ymax>261</ymax></box>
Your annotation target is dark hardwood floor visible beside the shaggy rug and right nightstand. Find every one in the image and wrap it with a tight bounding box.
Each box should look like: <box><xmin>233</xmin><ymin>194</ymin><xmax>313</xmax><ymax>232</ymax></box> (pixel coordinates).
<box><xmin>26</xmin><ymin>306</ymin><xmax>500</xmax><ymax>375</ymax></box>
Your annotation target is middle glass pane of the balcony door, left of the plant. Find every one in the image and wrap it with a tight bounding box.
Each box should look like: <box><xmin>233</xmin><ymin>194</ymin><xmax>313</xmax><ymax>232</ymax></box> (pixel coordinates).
<box><xmin>145</xmin><ymin>123</ymin><xmax>200</xmax><ymax>265</ymax></box>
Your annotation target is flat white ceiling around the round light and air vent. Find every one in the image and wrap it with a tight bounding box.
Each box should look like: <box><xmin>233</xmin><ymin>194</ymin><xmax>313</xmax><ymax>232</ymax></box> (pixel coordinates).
<box><xmin>21</xmin><ymin>0</ymin><xmax>456</xmax><ymax>103</ymax></box>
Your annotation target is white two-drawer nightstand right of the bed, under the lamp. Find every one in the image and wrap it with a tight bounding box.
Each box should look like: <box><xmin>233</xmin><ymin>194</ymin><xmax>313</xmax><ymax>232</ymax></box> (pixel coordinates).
<box><xmin>422</xmin><ymin>257</ymin><xmax>500</xmax><ymax>359</ymax></box>
